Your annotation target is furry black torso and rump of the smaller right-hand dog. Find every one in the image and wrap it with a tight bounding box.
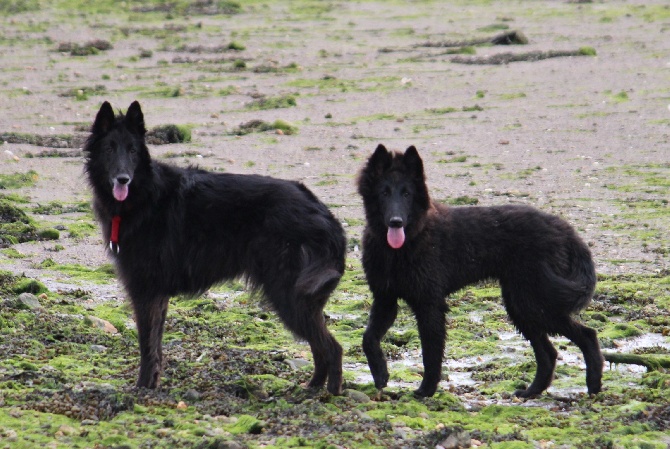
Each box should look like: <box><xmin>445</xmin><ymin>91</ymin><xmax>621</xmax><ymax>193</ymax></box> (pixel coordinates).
<box><xmin>436</xmin><ymin>205</ymin><xmax>596</xmax><ymax>313</ymax></box>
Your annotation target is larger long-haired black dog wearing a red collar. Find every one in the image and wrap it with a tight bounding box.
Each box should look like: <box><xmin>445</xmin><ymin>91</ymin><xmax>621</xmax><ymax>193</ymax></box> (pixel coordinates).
<box><xmin>84</xmin><ymin>102</ymin><xmax>346</xmax><ymax>394</ymax></box>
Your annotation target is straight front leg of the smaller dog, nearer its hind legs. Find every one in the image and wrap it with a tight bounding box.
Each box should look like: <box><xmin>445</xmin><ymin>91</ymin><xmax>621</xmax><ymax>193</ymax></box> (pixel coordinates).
<box><xmin>408</xmin><ymin>299</ymin><xmax>447</xmax><ymax>397</ymax></box>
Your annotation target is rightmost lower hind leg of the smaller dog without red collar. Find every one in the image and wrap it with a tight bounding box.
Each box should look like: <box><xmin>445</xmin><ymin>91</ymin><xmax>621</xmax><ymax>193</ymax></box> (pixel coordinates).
<box><xmin>558</xmin><ymin>317</ymin><xmax>603</xmax><ymax>394</ymax></box>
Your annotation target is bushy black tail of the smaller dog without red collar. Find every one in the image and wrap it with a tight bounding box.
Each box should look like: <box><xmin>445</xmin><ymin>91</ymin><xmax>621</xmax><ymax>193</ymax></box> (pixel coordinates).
<box><xmin>541</xmin><ymin>242</ymin><xmax>596</xmax><ymax>313</ymax></box>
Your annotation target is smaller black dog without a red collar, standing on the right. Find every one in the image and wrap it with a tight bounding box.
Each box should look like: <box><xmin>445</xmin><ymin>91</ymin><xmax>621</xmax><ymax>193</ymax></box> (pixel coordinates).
<box><xmin>358</xmin><ymin>145</ymin><xmax>603</xmax><ymax>397</ymax></box>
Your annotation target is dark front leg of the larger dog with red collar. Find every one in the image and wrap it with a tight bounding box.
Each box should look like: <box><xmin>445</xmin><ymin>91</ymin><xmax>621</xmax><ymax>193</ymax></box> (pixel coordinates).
<box><xmin>133</xmin><ymin>298</ymin><xmax>168</xmax><ymax>388</ymax></box>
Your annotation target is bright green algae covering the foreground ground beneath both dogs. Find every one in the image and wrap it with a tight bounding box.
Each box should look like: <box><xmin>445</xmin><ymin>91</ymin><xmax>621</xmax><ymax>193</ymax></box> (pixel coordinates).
<box><xmin>0</xmin><ymin>268</ymin><xmax>670</xmax><ymax>448</ymax></box>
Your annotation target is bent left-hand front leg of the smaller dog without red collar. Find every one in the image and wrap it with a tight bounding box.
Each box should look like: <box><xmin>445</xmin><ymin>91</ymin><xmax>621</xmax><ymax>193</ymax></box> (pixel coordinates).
<box><xmin>363</xmin><ymin>294</ymin><xmax>398</xmax><ymax>390</ymax></box>
